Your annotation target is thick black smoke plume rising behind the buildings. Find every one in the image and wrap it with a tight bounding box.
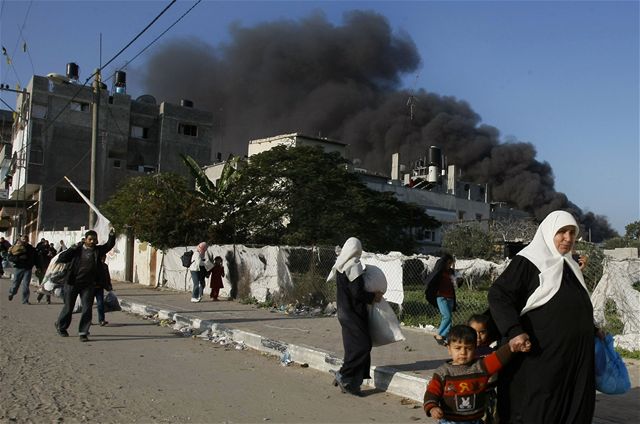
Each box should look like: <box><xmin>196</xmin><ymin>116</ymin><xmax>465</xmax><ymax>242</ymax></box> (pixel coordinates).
<box><xmin>139</xmin><ymin>11</ymin><xmax>615</xmax><ymax>241</ymax></box>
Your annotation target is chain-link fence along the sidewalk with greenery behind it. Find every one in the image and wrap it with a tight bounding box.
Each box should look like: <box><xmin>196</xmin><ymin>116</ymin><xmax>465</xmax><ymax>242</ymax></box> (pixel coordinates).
<box><xmin>231</xmin><ymin>245</ymin><xmax>640</xmax><ymax>340</ymax></box>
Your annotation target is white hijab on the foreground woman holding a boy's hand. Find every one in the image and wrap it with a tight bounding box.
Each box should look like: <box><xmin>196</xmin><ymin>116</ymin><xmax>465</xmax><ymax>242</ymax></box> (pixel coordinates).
<box><xmin>518</xmin><ymin>211</ymin><xmax>587</xmax><ymax>316</ymax></box>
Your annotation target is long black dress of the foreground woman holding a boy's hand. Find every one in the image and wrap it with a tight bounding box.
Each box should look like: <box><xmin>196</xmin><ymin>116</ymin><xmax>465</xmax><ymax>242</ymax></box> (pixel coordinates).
<box><xmin>489</xmin><ymin>256</ymin><xmax>595</xmax><ymax>424</ymax></box>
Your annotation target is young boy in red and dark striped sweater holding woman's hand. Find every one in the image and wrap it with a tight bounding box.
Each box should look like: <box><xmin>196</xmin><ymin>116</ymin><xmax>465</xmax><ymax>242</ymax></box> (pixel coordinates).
<box><xmin>423</xmin><ymin>325</ymin><xmax>511</xmax><ymax>424</ymax></box>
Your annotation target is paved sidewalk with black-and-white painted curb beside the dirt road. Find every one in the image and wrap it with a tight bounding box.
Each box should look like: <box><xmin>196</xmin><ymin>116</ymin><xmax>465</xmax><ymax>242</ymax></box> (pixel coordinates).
<box><xmin>114</xmin><ymin>282</ymin><xmax>640</xmax><ymax>406</ymax></box>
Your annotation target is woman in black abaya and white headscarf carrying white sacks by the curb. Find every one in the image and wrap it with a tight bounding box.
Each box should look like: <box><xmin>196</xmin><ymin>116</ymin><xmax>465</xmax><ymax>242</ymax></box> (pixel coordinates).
<box><xmin>327</xmin><ymin>237</ymin><xmax>382</xmax><ymax>396</ymax></box>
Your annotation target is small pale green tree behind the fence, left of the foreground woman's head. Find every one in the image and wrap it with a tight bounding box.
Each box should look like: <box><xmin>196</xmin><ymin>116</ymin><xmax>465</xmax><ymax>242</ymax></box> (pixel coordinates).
<box><xmin>442</xmin><ymin>225</ymin><xmax>494</xmax><ymax>260</ymax></box>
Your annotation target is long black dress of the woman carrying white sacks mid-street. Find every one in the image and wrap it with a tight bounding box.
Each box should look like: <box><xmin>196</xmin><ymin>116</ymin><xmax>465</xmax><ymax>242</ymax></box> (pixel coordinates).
<box><xmin>336</xmin><ymin>272</ymin><xmax>375</xmax><ymax>387</ymax></box>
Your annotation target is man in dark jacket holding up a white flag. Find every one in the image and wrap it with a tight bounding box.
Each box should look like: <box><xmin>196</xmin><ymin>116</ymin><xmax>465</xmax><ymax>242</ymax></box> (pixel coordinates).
<box><xmin>55</xmin><ymin>229</ymin><xmax>116</xmax><ymax>342</ymax></box>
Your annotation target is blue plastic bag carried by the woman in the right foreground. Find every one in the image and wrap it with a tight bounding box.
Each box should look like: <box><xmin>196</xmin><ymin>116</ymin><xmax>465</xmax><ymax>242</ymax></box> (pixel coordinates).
<box><xmin>595</xmin><ymin>334</ymin><xmax>631</xmax><ymax>395</ymax></box>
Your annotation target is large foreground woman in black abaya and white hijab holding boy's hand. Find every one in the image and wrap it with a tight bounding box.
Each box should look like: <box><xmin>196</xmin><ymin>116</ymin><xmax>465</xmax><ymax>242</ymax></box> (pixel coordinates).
<box><xmin>489</xmin><ymin>211</ymin><xmax>598</xmax><ymax>424</ymax></box>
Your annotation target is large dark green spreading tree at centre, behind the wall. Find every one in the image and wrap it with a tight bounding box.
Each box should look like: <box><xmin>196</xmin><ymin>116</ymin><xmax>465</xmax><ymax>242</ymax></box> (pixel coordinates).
<box><xmin>222</xmin><ymin>146</ymin><xmax>438</xmax><ymax>252</ymax></box>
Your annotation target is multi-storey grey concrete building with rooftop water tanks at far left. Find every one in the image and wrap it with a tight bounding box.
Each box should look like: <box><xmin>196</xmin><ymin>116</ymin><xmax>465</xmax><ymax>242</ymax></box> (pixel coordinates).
<box><xmin>0</xmin><ymin>64</ymin><xmax>213</xmax><ymax>237</ymax></box>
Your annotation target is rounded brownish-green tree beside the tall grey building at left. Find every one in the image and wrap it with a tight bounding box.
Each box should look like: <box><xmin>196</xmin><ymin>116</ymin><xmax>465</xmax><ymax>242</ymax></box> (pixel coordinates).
<box><xmin>101</xmin><ymin>173</ymin><xmax>210</xmax><ymax>249</ymax></box>
